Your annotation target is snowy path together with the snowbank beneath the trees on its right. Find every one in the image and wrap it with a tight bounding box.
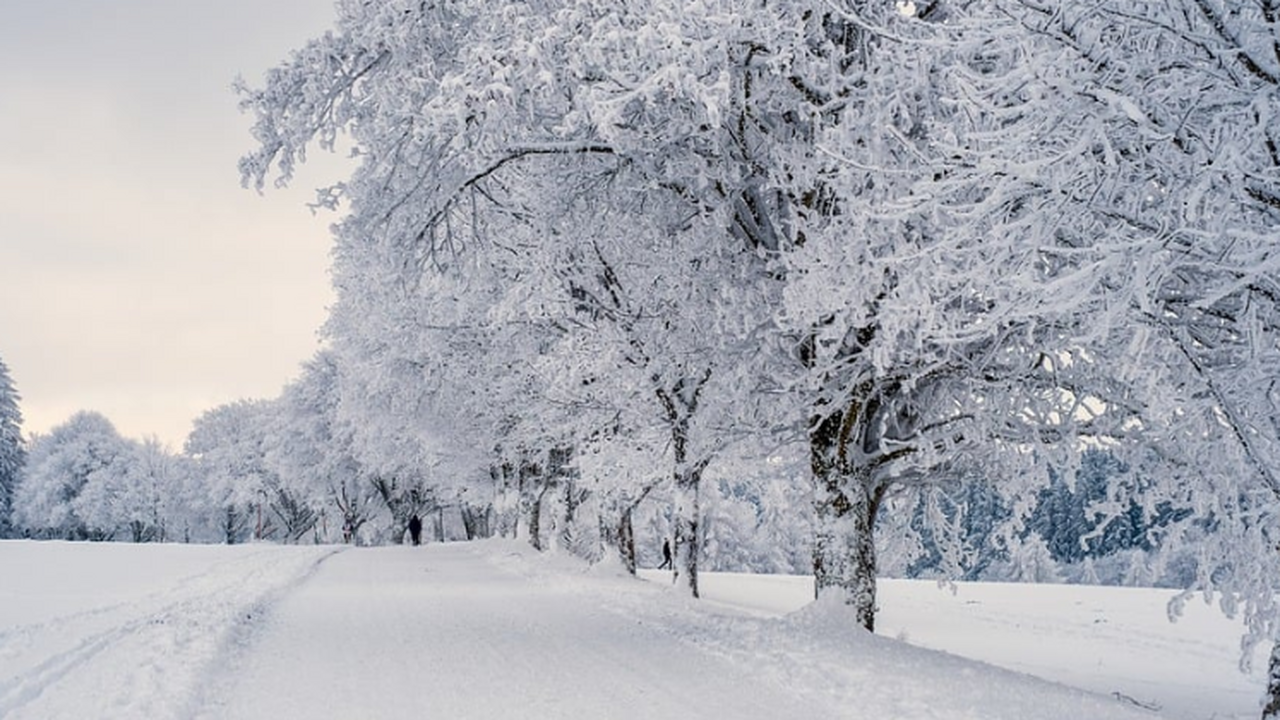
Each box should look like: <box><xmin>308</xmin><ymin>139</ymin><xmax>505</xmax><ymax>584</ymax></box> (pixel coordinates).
<box><xmin>197</xmin><ymin>541</ymin><xmax>1156</xmax><ymax>720</ymax></box>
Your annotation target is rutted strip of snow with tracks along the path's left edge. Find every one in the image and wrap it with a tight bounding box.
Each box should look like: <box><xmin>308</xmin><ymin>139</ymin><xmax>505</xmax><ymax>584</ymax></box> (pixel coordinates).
<box><xmin>0</xmin><ymin>548</ymin><xmax>337</xmax><ymax>720</ymax></box>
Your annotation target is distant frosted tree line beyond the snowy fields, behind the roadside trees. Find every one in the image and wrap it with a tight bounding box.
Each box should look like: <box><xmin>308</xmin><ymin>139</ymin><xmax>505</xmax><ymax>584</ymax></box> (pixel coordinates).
<box><xmin>0</xmin><ymin>354</ymin><xmax>1194</xmax><ymax>587</ymax></box>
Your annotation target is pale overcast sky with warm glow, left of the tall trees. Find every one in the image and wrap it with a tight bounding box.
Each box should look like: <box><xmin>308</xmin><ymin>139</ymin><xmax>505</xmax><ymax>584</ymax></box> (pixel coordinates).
<box><xmin>0</xmin><ymin>0</ymin><xmax>346</xmax><ymax>450</ymax></box>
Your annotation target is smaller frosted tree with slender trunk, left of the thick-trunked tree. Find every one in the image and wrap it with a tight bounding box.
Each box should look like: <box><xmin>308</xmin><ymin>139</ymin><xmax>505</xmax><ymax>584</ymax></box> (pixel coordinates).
<box><xmin>519</xmin><ymin>184</ymin><xmax>788</xmax><ymax>596</ymax></box>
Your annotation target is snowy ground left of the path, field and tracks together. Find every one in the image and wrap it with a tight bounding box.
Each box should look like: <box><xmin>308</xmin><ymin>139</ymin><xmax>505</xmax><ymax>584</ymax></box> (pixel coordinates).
<box><xmin>0</xmin><ymin>541</ymin><xmax>334</xmax><ymax>720</ymax></box>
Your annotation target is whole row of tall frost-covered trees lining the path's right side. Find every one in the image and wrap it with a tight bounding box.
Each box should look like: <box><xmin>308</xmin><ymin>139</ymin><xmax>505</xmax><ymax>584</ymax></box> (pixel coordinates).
<box><xmin>241</xmin><ymin>0</ymin><xmax>1280</xmax><ymax>716</ymax></box>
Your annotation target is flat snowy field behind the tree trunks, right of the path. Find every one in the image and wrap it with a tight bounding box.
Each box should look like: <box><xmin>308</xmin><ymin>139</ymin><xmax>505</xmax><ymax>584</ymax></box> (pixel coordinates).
<box><xmin>670</xmin><ymin>570</ymin><xmax>1270</xmax><ymax>720</ymax></box>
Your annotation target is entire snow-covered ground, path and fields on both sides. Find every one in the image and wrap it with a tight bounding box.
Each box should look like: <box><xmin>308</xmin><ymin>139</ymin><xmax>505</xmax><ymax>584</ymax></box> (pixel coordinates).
<box><xmin>0</xmin><ymin>541</ymin><xmax>1263</xmax><ymax>720</ymax></box>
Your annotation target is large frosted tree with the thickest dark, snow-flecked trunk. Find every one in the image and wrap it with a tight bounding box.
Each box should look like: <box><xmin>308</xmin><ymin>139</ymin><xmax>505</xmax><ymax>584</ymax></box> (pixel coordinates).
<box><xmin>757</xmin><ymin>3</ymin><xmax>1152</xmax><ymax>628</ymax></box>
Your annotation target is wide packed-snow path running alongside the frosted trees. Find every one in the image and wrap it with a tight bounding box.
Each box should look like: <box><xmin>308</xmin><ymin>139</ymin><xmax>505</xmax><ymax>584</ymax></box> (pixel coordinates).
<box><xmin>193</xmin><ymin>544</ymin><xmax>829</xmax><ymax>720</ymax></box>
